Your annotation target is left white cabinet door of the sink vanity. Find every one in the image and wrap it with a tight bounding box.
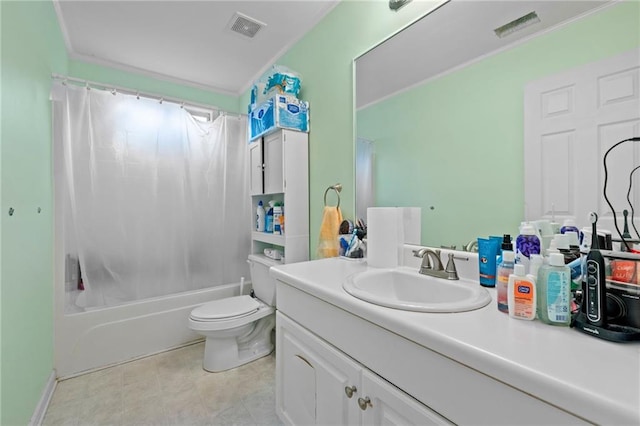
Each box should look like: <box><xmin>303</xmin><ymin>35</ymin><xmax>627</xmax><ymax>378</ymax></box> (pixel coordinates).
<box><xmin>276</xmin><ymin>313</ymin><xmax>361</xmax><ymax>425</ymax></box>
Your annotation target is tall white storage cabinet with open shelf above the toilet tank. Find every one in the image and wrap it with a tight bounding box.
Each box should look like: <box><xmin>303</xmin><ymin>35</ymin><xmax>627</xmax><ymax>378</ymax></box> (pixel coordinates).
<box><xmin>248</xmin><ymin>129</ymin><xmax>309</xmax><ymax>263</ymax></box>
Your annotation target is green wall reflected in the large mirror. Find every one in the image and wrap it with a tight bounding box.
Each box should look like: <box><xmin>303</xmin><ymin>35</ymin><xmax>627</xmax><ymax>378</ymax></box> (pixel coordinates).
<box><xmin>357</xmin><ymin>1</ymin><xmax>640</xmax><ymax>247</ymax></box>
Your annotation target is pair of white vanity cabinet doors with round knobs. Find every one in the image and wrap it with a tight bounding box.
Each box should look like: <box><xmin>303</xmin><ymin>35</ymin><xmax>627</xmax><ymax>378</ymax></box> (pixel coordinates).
<box><xmin>276</xmin><ymin>312</ymin><xmax>451</xmax><ymax>425</ymax></box>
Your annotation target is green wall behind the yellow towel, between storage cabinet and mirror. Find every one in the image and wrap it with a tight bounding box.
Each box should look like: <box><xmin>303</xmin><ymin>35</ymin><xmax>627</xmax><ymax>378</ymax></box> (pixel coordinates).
<box><xmin>242</xmin><ymin>0</ymin><xmax>450</xmax><ymax>257</ymax></box>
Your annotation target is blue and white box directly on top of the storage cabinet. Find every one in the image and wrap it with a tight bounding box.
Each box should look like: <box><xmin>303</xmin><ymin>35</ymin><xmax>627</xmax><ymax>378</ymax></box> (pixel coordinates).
<box><xmin>249</xmin><ymin>95</ymin><xmax>309</xmax><ymax>141</ymax></box>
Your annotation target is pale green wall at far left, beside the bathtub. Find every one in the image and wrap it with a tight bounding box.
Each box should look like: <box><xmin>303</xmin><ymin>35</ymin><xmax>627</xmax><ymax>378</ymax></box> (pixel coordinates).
<box><xmin>0</xmin><ymin>1</ymin><xmax>67</xmax><ymax>425</ymax></box>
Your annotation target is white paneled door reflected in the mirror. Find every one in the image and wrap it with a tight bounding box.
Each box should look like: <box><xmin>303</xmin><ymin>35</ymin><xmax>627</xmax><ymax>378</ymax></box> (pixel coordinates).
<box><xmin>524</xmin><ymin>49</ymin><xmax>640</xmax><ymax>239</ymax></box>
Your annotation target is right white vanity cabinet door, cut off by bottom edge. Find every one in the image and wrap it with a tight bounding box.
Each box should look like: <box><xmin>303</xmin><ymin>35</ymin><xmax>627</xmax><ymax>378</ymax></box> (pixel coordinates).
<box><xmin>358</xmin><ymin>370</ymin><xmax>453</xmax><ymax>426</ymax></box>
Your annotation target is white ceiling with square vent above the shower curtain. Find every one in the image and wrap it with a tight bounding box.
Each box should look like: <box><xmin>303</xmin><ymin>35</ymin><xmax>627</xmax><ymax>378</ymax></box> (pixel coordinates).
<box><xmin>54</xmin><ymin>0</ymin><xmax>338</xmax><ymax>95</ymax></box>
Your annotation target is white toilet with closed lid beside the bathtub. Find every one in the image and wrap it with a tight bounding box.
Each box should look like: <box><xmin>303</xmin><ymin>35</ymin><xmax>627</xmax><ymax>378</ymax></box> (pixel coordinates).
<box><xmin>189</xmin><ymin>255</ymin><xmax>277</xmax><ymax>372</ymax></box>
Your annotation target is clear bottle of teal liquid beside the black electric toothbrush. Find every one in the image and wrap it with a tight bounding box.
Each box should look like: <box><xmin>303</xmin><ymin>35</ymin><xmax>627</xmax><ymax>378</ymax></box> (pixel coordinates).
<box><xmin>537</xmin><ymin>253</ymin><xmax>571</xmax><ymax>326</ymax></box>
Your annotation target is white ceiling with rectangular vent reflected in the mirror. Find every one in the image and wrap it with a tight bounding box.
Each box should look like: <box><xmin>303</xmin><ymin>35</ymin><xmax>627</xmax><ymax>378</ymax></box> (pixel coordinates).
<box><xmin>356</xmin><ymin>0</ymin><xmax>612</xmax><ymax>108</ymax></box>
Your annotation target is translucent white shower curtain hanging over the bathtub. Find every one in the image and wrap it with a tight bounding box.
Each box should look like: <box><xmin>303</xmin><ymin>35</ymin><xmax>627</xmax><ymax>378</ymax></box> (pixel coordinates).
<box><xmin>54</xmin><ymin>83</ymin><xmax>251</xmax><ymax>307</ymax></box>
